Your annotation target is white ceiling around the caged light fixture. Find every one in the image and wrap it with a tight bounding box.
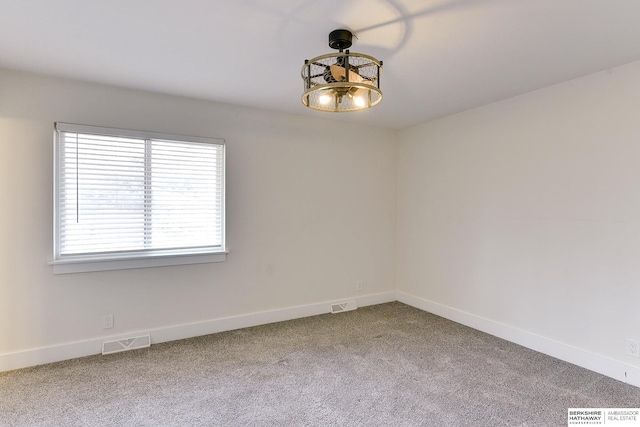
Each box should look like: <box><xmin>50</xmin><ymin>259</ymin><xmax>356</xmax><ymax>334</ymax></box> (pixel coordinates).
<box><xmin>0</xmin><ymin>0</ymin><xmax>640</xmax><ymax>129</ymax></box>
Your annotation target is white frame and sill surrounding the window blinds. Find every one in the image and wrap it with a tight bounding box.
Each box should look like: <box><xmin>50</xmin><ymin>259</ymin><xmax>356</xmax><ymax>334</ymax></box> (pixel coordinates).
<box><xmin>48</xmin><ymin>122</ymin><xmax>228</xmax><ymax>274</ymax></box>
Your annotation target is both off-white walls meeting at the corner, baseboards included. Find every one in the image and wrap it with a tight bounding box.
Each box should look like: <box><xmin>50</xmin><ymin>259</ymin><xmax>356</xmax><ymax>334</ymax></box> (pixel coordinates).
<box><xmin>5</xmin><ymin>58</ymin><xmax>640</xmax><ymax>385</ymax></box>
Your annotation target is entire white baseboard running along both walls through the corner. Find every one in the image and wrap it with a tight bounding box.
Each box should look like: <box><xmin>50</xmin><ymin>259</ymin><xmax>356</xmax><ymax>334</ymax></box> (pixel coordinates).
<box><xmin>6</xmin><ymin>291</ymin><xmax>640</xmax><ymax>387</ymax></box>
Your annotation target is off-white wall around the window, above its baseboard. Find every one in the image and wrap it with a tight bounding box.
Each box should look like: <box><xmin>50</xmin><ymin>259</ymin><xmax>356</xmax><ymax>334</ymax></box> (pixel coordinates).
<box><xmin>0</xmin><ymin>70</ymin><xmax>396</xmax><ymax>370</ymax></box>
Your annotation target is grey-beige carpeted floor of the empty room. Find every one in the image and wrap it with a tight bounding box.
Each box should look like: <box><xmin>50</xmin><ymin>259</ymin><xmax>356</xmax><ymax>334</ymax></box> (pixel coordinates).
<box><xmin>0</xmin><ymin>303</ymin><xmax>640</xmax><ymax>427</ymax></box>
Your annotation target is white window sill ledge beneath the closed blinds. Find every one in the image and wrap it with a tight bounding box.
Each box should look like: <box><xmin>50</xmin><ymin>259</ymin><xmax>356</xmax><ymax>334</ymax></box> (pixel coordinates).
<box><xmin>48</xmin><ymin>252</ymin><xmax>227</xmax><ymax>274</ymax></box>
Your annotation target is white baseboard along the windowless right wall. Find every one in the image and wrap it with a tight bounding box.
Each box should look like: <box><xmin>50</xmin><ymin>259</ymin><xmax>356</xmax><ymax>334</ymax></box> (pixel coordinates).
<box><xmin>396</xmin><ymin>291</ymin><xmax>640</xmax><ymax>387</ymax></box>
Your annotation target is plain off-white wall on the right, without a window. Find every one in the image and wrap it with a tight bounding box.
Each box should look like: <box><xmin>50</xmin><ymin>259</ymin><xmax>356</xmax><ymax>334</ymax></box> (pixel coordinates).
<box><xmin>397</xmin><ymin>62</ymin><xmax>640</xmax><ymax>384</ymax></box>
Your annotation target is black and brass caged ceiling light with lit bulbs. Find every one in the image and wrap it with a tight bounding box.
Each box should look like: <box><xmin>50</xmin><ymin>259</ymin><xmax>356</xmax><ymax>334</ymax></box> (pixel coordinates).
<box><xmin>302</xmin><ymin>30</ymin><xmax>382</xmax><ymax>112</ymax></box>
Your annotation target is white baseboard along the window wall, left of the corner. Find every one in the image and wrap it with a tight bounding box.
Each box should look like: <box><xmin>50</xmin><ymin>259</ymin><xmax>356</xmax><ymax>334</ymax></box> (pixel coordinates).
<box><xmin>0</xmin><ymin>291</ymin><xmax>396</xmax><ymax>372</ymax></box>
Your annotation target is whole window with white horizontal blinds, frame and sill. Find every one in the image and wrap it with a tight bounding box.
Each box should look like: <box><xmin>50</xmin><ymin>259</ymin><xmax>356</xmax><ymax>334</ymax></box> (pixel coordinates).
<box><xmin>52</xmin><ymin>123</ymin><xmax>225</xmax><ymax>273</ymax></box>
